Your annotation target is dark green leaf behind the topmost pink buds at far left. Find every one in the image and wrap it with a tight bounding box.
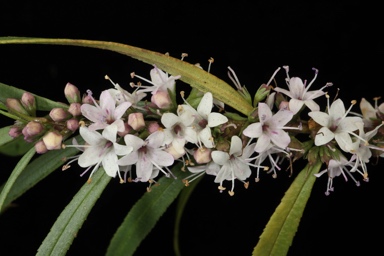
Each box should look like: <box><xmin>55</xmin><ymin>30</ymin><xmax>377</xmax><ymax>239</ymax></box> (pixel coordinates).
<box><xmin>0</xmin><ymin>81</ymin><xmax>68</xmax><ymax>111</ymax></box>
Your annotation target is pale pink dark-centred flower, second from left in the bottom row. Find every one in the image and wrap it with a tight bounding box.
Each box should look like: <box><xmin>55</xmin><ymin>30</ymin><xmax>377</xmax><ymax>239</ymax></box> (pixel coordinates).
<box><xmin>118</xmin><ymin>131</ymin><xmax>174</xmax><ymax>182</ymax></box>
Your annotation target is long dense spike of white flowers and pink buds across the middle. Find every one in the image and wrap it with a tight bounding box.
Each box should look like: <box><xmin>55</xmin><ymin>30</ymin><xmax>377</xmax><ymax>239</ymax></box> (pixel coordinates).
<box><xmin>7</xmin><ymin>62</ymin><xmax>384</xmax><ymax>195</ymax></box>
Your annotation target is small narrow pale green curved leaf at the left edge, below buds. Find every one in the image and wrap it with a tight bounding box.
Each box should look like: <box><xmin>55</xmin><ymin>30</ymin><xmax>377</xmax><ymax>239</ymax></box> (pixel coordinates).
<box><xmin>0</xmin><ymin>148</ymin><xmax>36</xmax><ymax>212</ymax></box>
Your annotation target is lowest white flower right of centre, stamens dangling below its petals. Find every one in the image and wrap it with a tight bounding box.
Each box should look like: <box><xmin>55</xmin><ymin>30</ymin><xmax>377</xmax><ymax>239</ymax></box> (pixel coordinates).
<box><xmin>211</xmin><ymin>136</ymin><xmax>254</xmax><ymax>196</ymax></box>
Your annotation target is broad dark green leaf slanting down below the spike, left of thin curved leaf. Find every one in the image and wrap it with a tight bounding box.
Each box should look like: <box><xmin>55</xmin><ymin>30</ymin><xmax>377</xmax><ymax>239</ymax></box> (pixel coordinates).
<box><xmin>107</xmin><ymin>164</ymin><xmax>188</xmax><ymax>256</ymax></box>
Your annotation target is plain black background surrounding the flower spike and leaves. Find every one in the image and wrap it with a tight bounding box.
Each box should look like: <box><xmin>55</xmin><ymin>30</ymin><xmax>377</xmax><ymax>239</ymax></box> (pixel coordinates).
<box><xmin>0</xmin><ymin>0</ymin><xmax>384</xmax><ymax>256</ymax></box>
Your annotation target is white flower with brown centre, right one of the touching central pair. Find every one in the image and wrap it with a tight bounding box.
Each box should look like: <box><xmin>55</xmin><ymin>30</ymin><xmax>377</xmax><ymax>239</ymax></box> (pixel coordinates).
<box><xmin>180</xmin><ymin>92</ymin><xmax>228</xmax><ymax>148</ymax></box>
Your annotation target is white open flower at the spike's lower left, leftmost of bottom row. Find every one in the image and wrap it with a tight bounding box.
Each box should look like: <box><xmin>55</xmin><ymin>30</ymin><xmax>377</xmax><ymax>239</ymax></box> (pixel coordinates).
<box><xmin>78</xmin><ymin>120</ymin><xmax>132</xmax><ymax>180</ymax></box>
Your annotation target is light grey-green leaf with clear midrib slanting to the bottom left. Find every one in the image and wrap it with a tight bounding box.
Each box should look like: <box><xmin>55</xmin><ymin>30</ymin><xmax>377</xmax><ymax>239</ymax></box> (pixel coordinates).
<box><xmin>36</xmin><ymin>168</ymin><xmax>111</xmax><ymax>256</ymax></box>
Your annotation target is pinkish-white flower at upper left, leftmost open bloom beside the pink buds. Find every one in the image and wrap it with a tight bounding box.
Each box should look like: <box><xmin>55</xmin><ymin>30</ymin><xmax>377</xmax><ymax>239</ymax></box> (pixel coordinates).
<box><xmin>81</xmin><ymin>90</ymin><xmax>132</xmax><ymax>132</ymax></box>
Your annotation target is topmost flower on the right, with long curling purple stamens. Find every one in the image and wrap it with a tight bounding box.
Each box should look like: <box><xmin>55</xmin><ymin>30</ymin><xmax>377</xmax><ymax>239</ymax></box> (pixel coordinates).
<box><xmin>274</xmin><ymin>66</ymin><xmax>332</xmax><ymax>114</ymax></box>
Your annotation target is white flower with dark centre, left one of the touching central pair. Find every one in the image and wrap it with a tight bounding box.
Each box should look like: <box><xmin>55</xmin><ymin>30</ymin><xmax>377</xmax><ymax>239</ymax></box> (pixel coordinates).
<box><xmin>161</xmin><ymin>105</ymin><xmax>198</xmax><ymax>155</ymax></box>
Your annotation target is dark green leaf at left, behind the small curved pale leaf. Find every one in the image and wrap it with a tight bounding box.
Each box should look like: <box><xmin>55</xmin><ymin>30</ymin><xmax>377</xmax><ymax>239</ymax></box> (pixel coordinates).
<box><xmin>0</xmin><ymin>135</ymin><xmax>82</xmax><ymax>210</ymax></box>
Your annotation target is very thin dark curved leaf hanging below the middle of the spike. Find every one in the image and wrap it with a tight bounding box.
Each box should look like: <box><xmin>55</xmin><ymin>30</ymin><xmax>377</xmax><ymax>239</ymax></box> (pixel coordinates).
<box><xmin>173</xmin><ymin>175</ymin><xmax>204</xmax><ymax>256</ymax></box>
